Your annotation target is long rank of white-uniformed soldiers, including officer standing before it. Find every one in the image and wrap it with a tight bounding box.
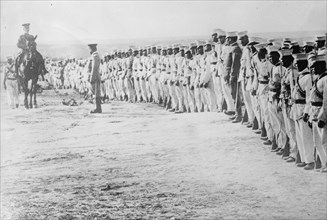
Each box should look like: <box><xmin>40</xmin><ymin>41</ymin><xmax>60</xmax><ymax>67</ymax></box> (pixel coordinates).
<box><xmin>3</xmin><ymin>25</ymin><xmax>327</xmax><ymax>172</ymax></box>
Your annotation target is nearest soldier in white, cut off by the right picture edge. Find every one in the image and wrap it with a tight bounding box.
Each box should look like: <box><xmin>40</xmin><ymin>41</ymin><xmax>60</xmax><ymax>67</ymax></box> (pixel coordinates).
<box><xmin>304</xmin><ymin>54</ymin><xmax>327</xmax><ymax>170</ymax></box>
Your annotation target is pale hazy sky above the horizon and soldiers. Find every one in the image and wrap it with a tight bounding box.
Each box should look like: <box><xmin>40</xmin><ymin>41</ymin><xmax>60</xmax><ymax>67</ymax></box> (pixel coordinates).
<box><xmin>1</xmin><ymin>0</ymin><xmax>327</xmax><ymax>44</ymax></box>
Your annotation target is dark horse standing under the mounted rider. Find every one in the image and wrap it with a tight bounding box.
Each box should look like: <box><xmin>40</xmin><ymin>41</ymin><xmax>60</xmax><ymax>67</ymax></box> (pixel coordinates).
<box><xmin>18</xmin><ymin>36</ymin><xmax>44</xmax><ymax>109</ymax></box>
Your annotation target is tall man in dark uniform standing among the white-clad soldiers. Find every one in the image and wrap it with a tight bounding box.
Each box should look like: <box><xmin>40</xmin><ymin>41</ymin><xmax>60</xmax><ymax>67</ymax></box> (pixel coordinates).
<box><xmin>224</xmin><ymin>32</ymin><xmax>242</xmax><ymax>123</ymax></box>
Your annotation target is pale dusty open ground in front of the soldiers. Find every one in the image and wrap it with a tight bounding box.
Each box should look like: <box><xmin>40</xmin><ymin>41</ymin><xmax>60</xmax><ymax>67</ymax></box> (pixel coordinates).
<box><xmin>1</xmin><ymin>88</ymin><xmax>327</xmax><ymax>220</ymax></box>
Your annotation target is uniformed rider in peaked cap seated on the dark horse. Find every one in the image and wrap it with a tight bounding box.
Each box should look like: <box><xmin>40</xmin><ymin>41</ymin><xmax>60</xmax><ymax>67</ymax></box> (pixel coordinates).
<box><xmin>15</xmin><ymin>23</ymin><xmax>48</xmax><ymax>74</ymax></box>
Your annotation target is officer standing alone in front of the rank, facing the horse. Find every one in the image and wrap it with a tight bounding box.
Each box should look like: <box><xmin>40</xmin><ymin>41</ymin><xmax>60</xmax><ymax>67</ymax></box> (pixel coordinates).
<box><xmin>88</xmin><ymin>44</ymin><xmax>102</xmax><ymax>114</ymax></box>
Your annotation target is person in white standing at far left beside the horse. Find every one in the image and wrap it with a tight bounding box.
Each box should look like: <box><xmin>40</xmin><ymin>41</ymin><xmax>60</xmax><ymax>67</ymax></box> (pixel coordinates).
<box><xmin>3</xmin><ymin>57</ymin><xmax>19</xmax><ymax>109</ymax></box>
